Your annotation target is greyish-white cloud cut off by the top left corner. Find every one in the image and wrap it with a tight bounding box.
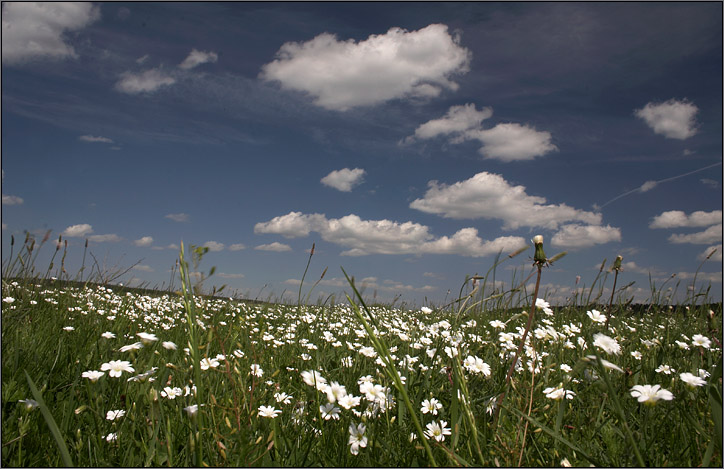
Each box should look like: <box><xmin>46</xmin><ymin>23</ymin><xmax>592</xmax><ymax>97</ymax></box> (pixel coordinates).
<box><xmin>2</xmin><ymin>2</ymin><xmax>101</xmax><ymax>64</ymax></box>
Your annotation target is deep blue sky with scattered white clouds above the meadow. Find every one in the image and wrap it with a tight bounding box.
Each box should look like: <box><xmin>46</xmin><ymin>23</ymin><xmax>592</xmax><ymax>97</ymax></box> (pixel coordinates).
<box><xmin>1</xmin><ymin>2</ymin><xmax>723</xmax><ymax>306</ymax></box>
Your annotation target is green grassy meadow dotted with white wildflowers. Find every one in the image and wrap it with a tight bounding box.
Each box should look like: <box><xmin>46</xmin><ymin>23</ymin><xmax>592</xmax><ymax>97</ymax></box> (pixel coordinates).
<box><xmin>1</xmin><ymin>236</ymin><xmax>722</xmax><ymax>467</ymax></box>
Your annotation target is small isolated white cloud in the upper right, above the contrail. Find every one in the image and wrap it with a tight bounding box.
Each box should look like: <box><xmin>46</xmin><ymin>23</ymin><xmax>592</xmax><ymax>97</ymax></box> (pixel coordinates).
<box><xmin>634</xmin><ymin>99</ymin><xmax>699</xmax><ymax>140</ymax></box>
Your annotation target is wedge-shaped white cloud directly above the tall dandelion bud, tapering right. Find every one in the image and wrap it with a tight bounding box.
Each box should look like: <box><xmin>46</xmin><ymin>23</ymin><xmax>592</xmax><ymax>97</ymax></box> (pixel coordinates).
<box><xmin>410</xmin><ymin>172</ymin><xmax>601</xmax><ymax>229</ymax></box>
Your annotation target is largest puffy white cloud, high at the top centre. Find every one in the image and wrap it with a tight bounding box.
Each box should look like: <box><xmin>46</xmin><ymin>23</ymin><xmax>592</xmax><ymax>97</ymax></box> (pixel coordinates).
<box><xmin>260</xmin><ymin>24</ymin><xmax>471</xmax><ymax>111</ymax></box>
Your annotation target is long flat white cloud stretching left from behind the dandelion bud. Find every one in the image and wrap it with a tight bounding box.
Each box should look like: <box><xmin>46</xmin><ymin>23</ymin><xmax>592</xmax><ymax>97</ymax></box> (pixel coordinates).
<box><xmin>254</xmin><ymin>212</ymin><xmax>525</xmax><ymax>257</ymax></box>
